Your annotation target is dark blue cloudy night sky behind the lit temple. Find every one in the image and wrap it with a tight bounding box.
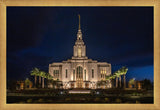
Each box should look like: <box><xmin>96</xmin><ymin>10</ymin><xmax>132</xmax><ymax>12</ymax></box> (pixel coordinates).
<box><xmin>7</xmin><ymin>7</ymin><xmax>153</xmax><ymax>81</ymax></box>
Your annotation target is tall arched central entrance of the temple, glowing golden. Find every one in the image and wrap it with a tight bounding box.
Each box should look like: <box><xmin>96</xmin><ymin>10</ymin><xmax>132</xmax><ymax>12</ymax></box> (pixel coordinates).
<box><xmin>76</xmin><ymin>66</ymin><xmax>83</xmax><ymax>88</ymax></box>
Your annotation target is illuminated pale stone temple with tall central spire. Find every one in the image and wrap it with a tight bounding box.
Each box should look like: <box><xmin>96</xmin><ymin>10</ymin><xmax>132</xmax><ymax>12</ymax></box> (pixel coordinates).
<box><xmin>49</xmin><ymin>15</ymin><xmax>111</xmax><ymax>89</ymax></box>
